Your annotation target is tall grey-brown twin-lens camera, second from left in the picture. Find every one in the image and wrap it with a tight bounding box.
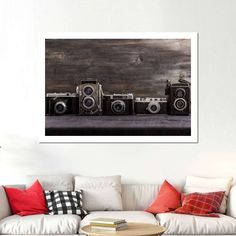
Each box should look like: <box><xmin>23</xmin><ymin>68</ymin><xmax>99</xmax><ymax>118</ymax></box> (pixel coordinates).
<box><xmin>76</xmin><ymin>79</ymin><xmax>103</xmax><ymax>115</ymax></box>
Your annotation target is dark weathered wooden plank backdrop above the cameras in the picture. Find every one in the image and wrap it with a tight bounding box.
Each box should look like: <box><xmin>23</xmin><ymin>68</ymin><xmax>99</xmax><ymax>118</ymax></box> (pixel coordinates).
<box><xmin>45</xmin><ymin>39</ymin><xmax>191</xmax><ymax>97</ymax></box>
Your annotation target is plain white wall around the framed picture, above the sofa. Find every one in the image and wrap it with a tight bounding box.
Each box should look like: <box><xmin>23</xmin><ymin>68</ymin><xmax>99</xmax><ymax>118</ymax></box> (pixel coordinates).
<box><xmin>0</xmin><ymin>0</ymin><xmax>236</xmax><ymax>184</ymax></box>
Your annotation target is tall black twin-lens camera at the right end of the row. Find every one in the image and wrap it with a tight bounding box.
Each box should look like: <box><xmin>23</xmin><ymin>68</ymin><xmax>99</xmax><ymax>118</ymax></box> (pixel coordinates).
<box><xmin>165</xmin><ymin>79</ymin><xmax>191</xmax><ymax>115</ymax></box>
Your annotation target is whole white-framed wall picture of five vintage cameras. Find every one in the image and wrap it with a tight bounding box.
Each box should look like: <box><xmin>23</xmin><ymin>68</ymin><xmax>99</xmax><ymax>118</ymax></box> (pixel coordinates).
<box><xmin>40</xmin><ymin>33</ymin><xmax>198</xmax><ymax>142</ymax></box>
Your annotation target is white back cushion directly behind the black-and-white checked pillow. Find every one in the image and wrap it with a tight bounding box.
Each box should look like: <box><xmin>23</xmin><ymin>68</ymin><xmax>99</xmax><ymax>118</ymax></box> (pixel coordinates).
<box><xmin>26</xmin><ymin>175</ymin><xmax>74</xmax><ymax>191</ymax></box>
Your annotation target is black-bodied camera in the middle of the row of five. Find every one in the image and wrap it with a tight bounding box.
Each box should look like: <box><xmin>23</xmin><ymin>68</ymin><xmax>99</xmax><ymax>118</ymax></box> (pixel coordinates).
<box><xmin>103</xmin><ymin>93</ymin><xmax>134</xmax><ymax>115</ymax></box>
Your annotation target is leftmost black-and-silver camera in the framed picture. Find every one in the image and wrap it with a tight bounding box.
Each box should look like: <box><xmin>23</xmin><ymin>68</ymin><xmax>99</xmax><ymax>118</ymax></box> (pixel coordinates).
<box><xmin>45</xmin><ymin>93</ymin><xmax>78</xmax><ymax>115</ymax></box>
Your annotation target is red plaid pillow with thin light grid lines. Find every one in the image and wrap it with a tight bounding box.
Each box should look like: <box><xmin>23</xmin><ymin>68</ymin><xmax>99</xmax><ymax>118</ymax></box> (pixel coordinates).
<box><xmin>174</xmin><ymin>192</ymin><xmax>225</xmax><ymax>217</ymax></box>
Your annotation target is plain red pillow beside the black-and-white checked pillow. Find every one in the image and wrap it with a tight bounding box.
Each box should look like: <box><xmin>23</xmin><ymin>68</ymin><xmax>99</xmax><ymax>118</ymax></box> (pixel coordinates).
<box><xmin>4</xmin><ymin>180</ymin><xmax>48</xmax><ymax>216</ymax></box>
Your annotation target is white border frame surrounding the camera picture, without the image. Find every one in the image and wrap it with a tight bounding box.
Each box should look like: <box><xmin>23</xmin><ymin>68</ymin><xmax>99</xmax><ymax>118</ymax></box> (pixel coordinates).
<box><xmin>38</xmin><ymin>32</ymin><xmax>198</xmax><ymax>143</ymax></box>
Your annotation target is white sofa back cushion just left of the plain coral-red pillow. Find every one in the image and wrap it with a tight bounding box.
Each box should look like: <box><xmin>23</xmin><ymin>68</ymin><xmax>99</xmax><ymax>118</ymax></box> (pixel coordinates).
<box><xmin>122</xmin><ymin>184</ymin><xmax>159</xmax><ymax>211</ymax></box>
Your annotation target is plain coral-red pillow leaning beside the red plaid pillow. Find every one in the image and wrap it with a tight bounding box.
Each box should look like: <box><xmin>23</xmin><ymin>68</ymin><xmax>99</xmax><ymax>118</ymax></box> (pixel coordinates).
<box><xmin>145</xmin><ymin>180</ymin><xmax>181</xmax><ymax>214</ymax></box>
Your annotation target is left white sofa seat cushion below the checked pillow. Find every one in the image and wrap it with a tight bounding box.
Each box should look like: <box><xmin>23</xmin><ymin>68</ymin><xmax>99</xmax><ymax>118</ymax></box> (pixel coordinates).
<box><xmin>0</xmin><ymin>215</ymin><xmax>81</xmax><ymax>234</ymax></box>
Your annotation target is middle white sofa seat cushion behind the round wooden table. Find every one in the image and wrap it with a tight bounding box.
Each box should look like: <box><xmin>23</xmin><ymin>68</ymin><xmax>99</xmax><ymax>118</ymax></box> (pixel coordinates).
<box><xmin>80</xmin><ymin>211</ymin><xmax>157</xmax><ymax>227</ymax></box>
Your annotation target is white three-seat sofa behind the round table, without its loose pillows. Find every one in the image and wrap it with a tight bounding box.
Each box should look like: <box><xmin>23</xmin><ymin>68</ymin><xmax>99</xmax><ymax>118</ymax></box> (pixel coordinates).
<box><xmin>0</xmin><ymin>175</ymin><xmax>236</xmax><ymax>235</ymax></box>
